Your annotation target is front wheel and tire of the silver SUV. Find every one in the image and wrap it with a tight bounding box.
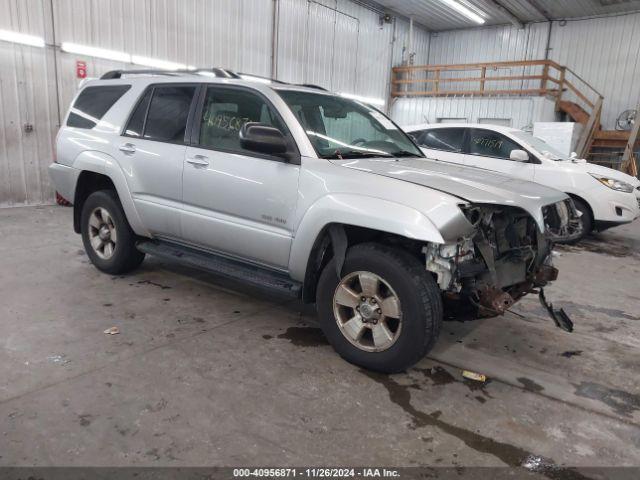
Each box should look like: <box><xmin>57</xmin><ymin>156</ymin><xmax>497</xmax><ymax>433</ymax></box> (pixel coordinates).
<box><xmin>316</xmin><ymin>243</ymin><xmax>443</xmax><ymax>373</ymax></box>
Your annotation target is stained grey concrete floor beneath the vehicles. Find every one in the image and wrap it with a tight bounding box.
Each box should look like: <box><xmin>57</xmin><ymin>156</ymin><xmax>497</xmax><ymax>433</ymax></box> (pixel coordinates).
<box><xmin>0</xmin><ymin>207</ymin><xmax>640</xmax><ymax>466</ymax></box>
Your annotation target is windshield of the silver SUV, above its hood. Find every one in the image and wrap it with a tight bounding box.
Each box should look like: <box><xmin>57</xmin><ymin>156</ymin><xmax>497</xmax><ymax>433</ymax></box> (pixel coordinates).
<box><xmin>278</xmin><ymin>90</ymin><xmax>424</xmax><ymax>159</ymax></box>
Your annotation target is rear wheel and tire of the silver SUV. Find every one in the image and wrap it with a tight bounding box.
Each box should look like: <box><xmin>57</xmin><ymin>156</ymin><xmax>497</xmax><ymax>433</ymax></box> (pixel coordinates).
<box><xmin>80</xmin><ymin>190</ymin><xmax>144</xmax><ymax>275</ymax></box>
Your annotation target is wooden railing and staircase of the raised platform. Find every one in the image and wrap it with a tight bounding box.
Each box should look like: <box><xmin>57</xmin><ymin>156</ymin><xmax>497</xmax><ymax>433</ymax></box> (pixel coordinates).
<box><xmin>391</xmin><ymin>60</ymin><xmax>640</xmax><ymax>176</ymax></box>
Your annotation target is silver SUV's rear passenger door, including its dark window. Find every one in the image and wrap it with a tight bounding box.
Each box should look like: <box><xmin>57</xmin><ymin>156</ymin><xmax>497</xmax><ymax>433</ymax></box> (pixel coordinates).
<box><xmin>116</xmin><ymin>84</ymin><xmax>199</xmax><ymax>239</ymax></box>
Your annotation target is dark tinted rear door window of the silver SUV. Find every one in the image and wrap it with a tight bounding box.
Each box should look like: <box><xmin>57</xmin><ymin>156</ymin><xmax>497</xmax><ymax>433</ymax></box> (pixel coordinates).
<box><xmin>143</xmin><ymin>85</ymin><xmax>196</xmax><ymax>143</ymax></box>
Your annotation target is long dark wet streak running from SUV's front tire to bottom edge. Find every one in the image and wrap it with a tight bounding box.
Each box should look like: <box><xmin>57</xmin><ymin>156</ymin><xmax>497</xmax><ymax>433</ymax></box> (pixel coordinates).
<box><xmin>360</xmin><ymin>369</ymin><xmax>589</xmax><ymax>480</ymax></box>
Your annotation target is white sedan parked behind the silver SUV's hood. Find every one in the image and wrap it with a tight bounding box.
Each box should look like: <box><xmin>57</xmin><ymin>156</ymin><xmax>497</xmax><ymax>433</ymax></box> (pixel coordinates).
<box><xmin>404</xmin><ymin>124</ymin><xmax>640</xmax><ymax>235</ymax></box>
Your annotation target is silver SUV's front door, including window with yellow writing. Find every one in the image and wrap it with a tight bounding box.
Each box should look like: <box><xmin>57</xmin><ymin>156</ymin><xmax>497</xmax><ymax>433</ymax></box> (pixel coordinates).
<box><xmin>182</xmin><ymin>86</ymin><xmax>300</xmax><ymax>270</ymax></box>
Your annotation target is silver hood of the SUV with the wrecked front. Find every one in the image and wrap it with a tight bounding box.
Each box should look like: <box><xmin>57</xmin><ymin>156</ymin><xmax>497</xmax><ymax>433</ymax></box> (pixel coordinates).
<box><xmin>332</xmin><ymin>158</ymin><xmax>568</xmax><ymax>231</ymax></box>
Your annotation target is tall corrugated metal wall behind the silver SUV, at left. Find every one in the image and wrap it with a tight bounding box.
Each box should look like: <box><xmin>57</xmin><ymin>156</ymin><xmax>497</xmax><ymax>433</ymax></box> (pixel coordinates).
<box><xmin>0</xmin><ymin>0</ymin><xmax>429</xmax><ymax>207</ymax></box>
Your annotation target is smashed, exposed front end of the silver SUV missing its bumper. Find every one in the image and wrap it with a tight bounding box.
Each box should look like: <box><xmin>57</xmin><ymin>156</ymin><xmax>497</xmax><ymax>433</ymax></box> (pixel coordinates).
<box><xmin>423</xmin><ymin>199</ymin><xmax>582</xmax><ymax>331</ymax></box>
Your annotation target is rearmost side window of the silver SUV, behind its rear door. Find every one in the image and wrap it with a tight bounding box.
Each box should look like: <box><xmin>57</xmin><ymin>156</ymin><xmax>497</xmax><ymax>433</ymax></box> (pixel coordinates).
<box><xmin>67</xmin><ymin>85</ymin><xmax>131</xmax><ymax>128</ymax></box>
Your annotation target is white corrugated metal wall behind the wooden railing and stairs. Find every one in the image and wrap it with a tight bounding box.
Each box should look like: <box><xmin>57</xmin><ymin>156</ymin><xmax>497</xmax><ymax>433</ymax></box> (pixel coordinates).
<box><xmin>392</xmin><ymin>13</ymin><xmax>640</xmax><ymax>129</ymax></box>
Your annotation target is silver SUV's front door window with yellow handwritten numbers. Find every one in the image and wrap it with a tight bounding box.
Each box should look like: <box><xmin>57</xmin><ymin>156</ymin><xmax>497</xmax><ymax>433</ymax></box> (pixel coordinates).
<box><xmin>198</xmin><ymin>87</ymin><xmax>286</xmax><ymax>152</ymax></box>
